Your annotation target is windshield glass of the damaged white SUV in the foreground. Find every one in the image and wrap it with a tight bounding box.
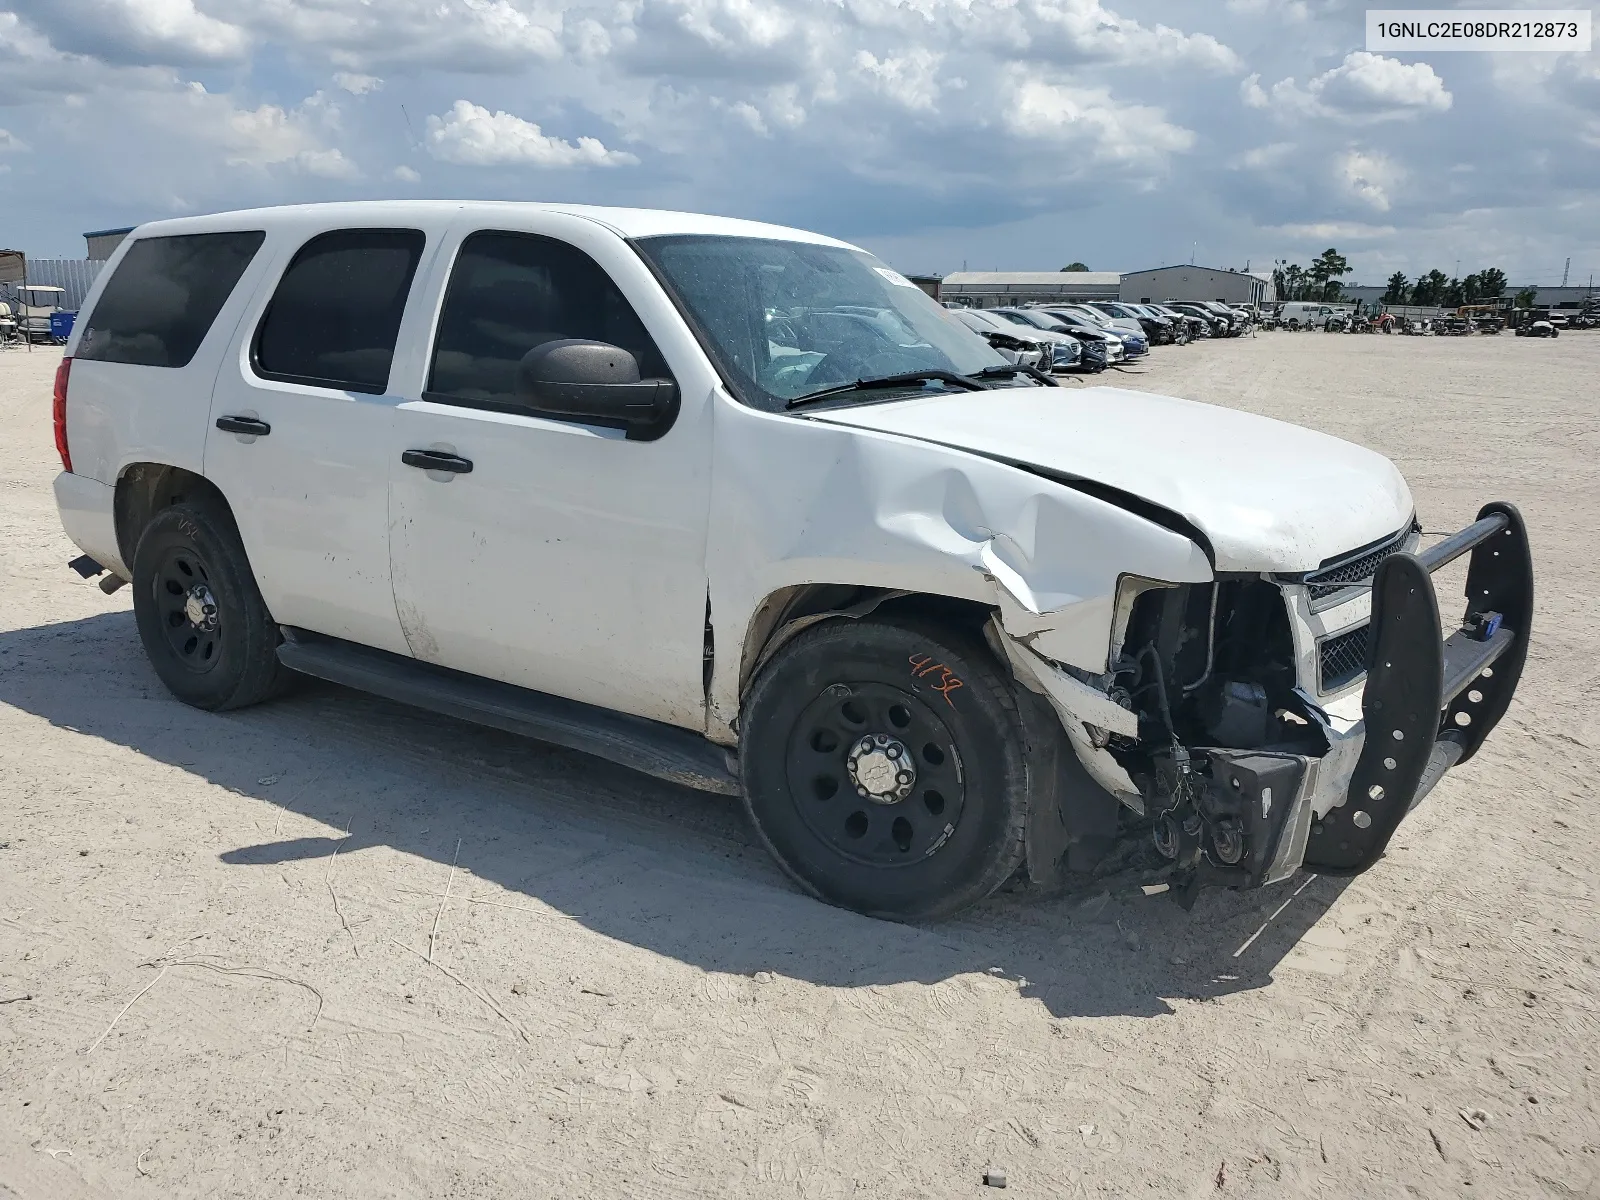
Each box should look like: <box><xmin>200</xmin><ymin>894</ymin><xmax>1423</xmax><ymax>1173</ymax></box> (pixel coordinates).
<box><xmin>635</xmin><ymin>235</ymin><xmax>1006</xmax><ymax>411</ymax></box>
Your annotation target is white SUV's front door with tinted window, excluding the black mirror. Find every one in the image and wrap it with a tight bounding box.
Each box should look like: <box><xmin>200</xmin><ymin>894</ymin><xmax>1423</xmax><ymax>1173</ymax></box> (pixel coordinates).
<box><xmin>389</xmin><ymin>225</ymin><xmax>710</xmax><ymax>730</ymax></box>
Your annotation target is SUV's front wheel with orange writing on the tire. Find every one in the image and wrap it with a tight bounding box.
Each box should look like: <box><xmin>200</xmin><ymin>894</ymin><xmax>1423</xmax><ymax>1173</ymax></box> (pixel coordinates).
<box><xmin>741</xmin><ymin>618</ymin><xmax>1029</xmax><ymax>920</ymax></box>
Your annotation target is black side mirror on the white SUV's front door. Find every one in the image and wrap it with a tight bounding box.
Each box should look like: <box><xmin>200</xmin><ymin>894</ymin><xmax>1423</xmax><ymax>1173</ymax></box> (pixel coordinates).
<box><xmin>517</xmin><ymin>338</ymin><xmax>678</xmax><ymax>442</ymax></box>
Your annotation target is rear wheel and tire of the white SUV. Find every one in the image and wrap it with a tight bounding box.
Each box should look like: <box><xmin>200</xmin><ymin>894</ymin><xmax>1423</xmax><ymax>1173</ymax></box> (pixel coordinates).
<box><xmin>133</xmin><ymin>501</ymin><xmax>293</xmax><ymax>712</ymax></box>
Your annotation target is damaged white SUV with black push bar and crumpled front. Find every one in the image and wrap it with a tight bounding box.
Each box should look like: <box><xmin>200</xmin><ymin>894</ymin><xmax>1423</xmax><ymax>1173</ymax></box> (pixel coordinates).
<box><xmin>54</xmin><ymin>203</ymin><xmax>1533</xmax><ymax>918</ymax></box>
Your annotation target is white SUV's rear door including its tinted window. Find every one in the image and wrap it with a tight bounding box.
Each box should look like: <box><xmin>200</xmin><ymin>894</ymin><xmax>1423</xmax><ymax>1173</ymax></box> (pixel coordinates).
<box><xmin>205</xmin><ymin>226</ymin><xmax>429</xmax><ymax>653</ymax></box>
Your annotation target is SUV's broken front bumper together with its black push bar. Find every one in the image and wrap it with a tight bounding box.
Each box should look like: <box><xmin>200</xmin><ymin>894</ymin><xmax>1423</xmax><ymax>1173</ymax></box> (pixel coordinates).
<box><xmin>1228</xmin><ymin>504</ymin><xmax>1533</xmax><ymax>886</ymax></box>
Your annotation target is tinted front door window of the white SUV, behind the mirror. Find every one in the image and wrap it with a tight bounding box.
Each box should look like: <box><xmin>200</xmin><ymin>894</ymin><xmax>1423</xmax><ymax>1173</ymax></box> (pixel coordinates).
<box><xmin>424</xmin><ymin>232</ymin><xmax>670</xmax><ymax>408</ymax></box>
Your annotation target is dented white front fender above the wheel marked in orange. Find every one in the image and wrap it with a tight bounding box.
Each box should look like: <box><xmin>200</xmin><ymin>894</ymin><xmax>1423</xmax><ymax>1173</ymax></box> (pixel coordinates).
<box><xmin>707</xmin><ymin>400</ymin><xmax>1211</xmax><ymax>736</ymax></box>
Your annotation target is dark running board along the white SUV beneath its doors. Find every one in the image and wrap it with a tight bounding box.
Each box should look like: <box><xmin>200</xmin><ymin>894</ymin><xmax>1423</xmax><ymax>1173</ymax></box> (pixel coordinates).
<box><xmin>278</xmin><ymin>626</ymin><xmax>739</xmax><ymax>795</ymax></box>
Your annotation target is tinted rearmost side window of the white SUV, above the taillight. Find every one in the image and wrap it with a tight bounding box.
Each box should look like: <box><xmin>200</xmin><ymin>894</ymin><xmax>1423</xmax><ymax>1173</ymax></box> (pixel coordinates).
<box><xmin>77</xmin><ymin>229</ymin><xmax>266</xmax><ymax>366</ymax></box>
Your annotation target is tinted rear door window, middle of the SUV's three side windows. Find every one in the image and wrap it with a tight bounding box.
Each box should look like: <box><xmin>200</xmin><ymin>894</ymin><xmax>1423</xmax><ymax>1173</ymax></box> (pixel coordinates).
<box><xmin>254</xmin><ymin>229</ymin><xmax>424</xmax><ymax>395</ymax></box>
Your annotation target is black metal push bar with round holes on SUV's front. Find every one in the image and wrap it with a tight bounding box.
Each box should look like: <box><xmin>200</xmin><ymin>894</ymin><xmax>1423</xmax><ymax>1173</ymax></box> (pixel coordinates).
<box><xmin>1304</xmin><ymin>504</ymin><xmax>1533</xmax><ymax>875</ymax></box>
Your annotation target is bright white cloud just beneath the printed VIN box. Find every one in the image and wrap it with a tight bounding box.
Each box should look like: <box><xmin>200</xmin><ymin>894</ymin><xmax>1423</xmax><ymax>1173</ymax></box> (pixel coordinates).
<box><xmin>1240</xmin><ymin>50</ymin><xmax>1454</xmax><ymax>123</ymax></box>
